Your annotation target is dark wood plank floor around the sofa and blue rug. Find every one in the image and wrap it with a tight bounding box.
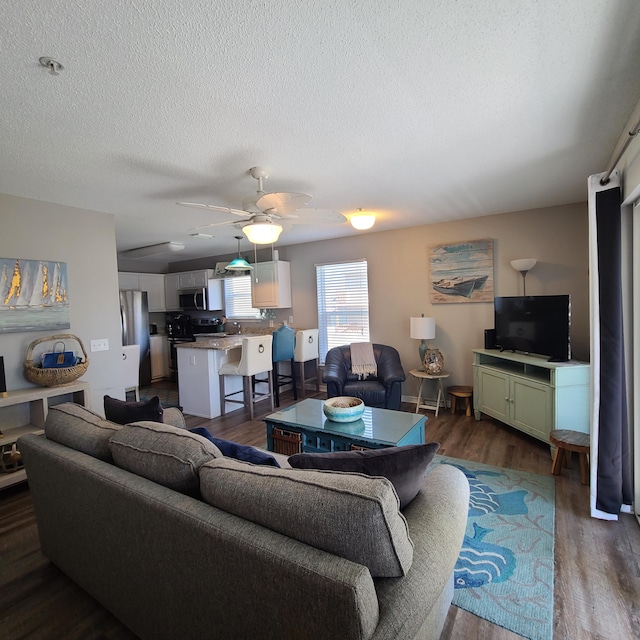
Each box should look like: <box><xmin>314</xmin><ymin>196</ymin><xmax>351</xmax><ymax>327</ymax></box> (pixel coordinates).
<box><xmin>0</xmin><ymin>384</ymin><xmax>640</xmax><ymax>640</ymax></box>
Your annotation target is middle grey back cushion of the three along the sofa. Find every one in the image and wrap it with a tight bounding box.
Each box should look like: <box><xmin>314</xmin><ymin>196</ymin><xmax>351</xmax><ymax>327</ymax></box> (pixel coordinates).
<box><xmin>111</xmin><ymin>422</ymin><xmax>222</xmax><ymax>496</ymax></box>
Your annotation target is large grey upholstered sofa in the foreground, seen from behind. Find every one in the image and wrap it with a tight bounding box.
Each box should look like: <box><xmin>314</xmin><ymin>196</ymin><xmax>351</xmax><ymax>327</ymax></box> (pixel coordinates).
<box><xmin>19</xmin><ymin>403</ymin><xmax>469</xmax><ymax>640</ymax></box>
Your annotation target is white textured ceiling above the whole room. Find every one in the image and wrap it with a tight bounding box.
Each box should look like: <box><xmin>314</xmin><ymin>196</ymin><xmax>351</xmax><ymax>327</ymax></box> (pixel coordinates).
<box><xmin>0</xmin><ymin>0</ymin><xmax>640</xmax><ymax>260</ymax></box>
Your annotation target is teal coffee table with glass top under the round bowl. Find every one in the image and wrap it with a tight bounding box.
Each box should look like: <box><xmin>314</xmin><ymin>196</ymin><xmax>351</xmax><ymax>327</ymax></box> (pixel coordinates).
<box><xmin>264</xmin><ymin>398</ymin><xmax>426</xmax><ymax>455</ymax></box>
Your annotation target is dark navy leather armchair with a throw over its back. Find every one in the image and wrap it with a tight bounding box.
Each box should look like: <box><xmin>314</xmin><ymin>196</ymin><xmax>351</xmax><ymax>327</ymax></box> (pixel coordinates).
<box><xmin>322</xmin><ymin>344</ymin><xmax>406</xmax><ymax>411</ymax></box>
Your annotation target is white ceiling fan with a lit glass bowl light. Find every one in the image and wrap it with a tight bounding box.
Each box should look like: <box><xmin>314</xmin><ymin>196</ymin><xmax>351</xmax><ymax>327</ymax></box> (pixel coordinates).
<box><xmin>177</xmin><ymin>167</ymin><xmax>347</xmax><ymax>244</ymax></box>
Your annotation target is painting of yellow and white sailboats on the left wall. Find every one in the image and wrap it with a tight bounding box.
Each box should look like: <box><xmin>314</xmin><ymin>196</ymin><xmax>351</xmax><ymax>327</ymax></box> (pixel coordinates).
<box><xmin>0</xmin><ymin>258</ymin><xmax>71</xmax><ymax>333</ymax></box>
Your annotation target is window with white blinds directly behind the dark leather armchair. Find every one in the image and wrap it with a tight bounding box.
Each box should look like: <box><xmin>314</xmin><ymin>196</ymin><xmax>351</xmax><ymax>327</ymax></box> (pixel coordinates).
<box><xmin>316</xmin><ymin>260</ymin><xmax>369</xmax><ymax>364</ymax></box>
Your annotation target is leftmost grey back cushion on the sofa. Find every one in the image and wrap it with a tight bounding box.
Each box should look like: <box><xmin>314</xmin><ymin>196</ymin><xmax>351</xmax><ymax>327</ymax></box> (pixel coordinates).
<box><xmin>44</xmin><ymin>402</ymin><xmax>122</xmax><ymax>462</ymax></box>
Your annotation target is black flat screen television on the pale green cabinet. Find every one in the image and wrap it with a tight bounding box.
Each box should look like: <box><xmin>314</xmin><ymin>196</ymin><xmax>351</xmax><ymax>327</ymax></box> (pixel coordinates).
<box><xmin>494</xmin><ymin>295</ymin><xmax>571</xmax><ymax>362</ymax></box>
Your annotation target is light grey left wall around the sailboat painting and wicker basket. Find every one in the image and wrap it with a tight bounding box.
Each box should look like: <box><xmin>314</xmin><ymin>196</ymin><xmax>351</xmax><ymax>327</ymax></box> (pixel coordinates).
<box><xmin>0</xmin><ymin>194</ymin><xmax>124</xmax><ymax>413</ymax></box>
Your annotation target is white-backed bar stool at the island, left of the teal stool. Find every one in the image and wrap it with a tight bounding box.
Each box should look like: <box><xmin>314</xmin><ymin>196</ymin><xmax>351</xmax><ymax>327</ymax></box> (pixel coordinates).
<box><xmin>218</xmin><ymin>335</ymin><xmax>273</xmax><ymax>420</ymax></box>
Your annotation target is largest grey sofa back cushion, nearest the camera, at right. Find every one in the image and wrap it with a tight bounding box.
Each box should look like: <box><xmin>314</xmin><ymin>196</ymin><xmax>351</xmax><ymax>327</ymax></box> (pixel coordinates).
<box><xmin>200</xmin><ymin>458</ymin><xmax>413</xmax><ymax>577</ymax></box>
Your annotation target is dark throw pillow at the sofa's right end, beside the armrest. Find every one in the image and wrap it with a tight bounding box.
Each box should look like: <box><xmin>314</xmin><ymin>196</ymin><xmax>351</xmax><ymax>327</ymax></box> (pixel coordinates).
<box><xmin>289</xmin><ymin>442</ymin><xmax>440</xmax><ymax>509</ymax></box>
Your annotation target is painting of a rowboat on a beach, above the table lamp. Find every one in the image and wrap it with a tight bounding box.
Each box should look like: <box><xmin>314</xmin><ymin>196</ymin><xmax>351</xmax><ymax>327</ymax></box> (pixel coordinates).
<box><xmin>429</xmin><ymin>239</ymin><xmax>493</xmax><ymax>304</ymax></box>
